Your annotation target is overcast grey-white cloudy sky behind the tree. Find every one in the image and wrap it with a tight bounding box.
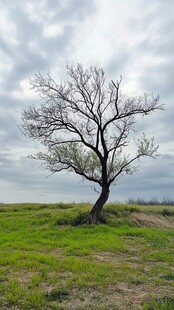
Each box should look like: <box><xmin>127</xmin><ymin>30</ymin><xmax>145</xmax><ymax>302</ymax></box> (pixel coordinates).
<box><xmin>0</xmin><ymin>0</ymin><xmax>174</xmax><ymax>203</ymax></box>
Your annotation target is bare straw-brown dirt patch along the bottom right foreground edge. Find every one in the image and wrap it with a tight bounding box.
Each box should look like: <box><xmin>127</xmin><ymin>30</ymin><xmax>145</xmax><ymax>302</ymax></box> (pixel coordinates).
<box><xmin>56</xmin><ymin>282</ymin><xmax>173</xmax><ymax>310</ymax></box>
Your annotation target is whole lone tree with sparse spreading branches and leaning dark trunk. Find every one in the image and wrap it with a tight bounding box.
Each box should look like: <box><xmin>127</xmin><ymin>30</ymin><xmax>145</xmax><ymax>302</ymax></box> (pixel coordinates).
<box><xmin>21</xmin><ymin>64</ymin><xmax>163</xmax><ymax>224</ymax></box>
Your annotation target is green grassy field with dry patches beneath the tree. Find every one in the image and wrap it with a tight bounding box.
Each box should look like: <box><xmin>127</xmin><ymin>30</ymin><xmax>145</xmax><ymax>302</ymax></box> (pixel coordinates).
<box><xmin>0</xmin><ymin>203</ymin><xmax>174</xmax><ymax>310</ymax></box>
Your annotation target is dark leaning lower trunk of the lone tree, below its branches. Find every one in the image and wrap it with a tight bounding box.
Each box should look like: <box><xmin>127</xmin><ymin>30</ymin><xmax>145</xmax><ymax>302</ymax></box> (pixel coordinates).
<box><xmin>89</xmin><ymin>186</ymin><xmax>109</xmax><ymax>224</ymax></box>
